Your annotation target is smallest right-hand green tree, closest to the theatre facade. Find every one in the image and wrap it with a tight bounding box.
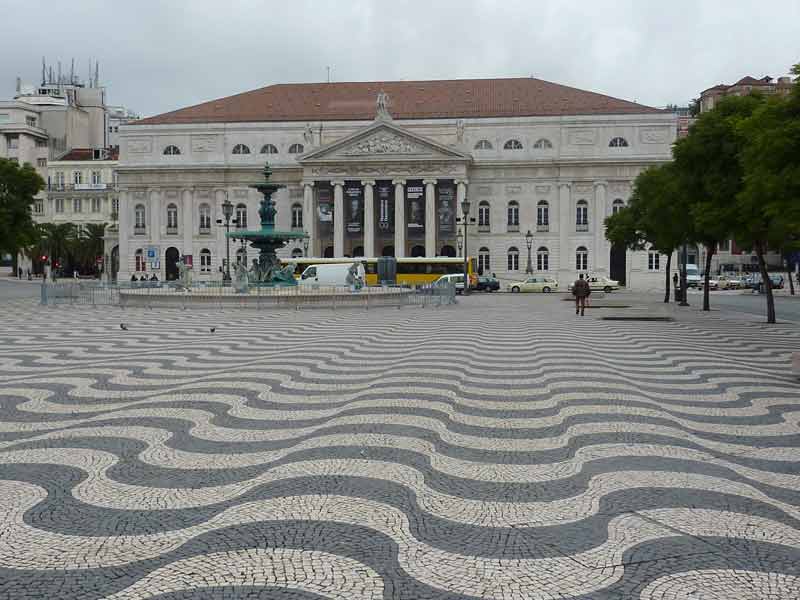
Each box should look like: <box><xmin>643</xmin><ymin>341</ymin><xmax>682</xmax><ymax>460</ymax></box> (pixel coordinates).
<box><xmin>606</xmin><ymin>163</ymin><xmax>692</xmax><ymax>302</ymax></box>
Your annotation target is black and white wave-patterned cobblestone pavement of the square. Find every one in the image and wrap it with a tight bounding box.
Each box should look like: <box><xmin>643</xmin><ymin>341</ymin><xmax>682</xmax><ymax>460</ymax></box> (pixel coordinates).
<box><xmin>0</xmin><ymin>295</ymin><xmax>800</xmax><ymax>600</ymax></box>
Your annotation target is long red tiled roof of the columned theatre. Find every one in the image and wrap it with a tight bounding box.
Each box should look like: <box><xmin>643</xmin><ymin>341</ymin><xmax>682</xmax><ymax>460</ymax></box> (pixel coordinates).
<box><xmin>136</xmin><ymin>78</ymin><xmax>662</xmax><ymax>126</ymax></box>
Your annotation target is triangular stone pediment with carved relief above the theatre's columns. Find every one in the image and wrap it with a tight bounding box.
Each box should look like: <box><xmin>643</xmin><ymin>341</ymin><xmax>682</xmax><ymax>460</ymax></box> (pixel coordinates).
<box><xmin>298</xmin><ymin>121</ymin><xmax>472</xmax><ymax>164</ymax></box>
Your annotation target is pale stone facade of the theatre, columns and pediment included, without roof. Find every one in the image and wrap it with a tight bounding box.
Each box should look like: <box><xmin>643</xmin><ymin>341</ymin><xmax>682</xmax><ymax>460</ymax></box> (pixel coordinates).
<box><xmin>112</xmin><ymin>86</ymin><xmax>676</xmax><ymax>288</ymax></box>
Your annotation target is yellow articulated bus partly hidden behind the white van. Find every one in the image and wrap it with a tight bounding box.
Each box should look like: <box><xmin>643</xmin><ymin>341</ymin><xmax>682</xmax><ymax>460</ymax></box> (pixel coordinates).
<box><xmin>281</xmin><ymin>256</ymin><xmax>478</xmax><ymax>286</ymax></box>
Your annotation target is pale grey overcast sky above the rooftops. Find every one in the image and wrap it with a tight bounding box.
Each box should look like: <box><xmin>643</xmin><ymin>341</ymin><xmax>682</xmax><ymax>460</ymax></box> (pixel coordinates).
<box><xmin>0</xmin><ymin>0</ymin><xmax>800</xmax><ymax>116</ymax></box>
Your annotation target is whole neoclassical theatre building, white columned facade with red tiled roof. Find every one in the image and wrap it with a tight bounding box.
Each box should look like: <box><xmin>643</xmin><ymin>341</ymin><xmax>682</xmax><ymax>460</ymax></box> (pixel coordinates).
<box><xmin>109</xmin><ymin>78</ymin><xmax>676</xmax><ymax>288</ymax></box>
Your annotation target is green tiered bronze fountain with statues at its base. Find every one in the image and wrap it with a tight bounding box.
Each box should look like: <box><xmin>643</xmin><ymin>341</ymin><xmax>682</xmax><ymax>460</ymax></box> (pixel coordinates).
<box><xmin>227</xmin><ymin>163</ymin><xmax>308</xmax><ymax>287</ymax></box>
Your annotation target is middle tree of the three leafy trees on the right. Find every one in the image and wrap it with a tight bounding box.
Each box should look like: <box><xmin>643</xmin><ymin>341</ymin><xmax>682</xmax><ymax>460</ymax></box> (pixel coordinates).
<box><xmin>673</xmin><ymin>95</ymin><xmax>763</xmax><ymax>310</ymax></box>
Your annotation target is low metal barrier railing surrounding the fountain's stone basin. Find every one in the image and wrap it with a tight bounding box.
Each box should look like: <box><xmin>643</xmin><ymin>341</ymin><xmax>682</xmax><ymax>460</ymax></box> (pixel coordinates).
<box><xmin>41</xmin><ymin>281</ymin><xmax>456</xmax><ymax>310</ymax></box>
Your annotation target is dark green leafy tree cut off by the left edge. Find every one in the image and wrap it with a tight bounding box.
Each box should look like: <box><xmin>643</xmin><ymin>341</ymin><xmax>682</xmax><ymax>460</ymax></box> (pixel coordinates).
<box><xmin>0</xmin><ymin>158</ymin><xmax>44</xmax><ymax>264</ymax></box>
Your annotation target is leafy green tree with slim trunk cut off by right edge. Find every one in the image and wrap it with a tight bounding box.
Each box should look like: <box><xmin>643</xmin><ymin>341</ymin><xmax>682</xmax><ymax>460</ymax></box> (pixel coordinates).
<box><xmin>735</xmin><ymin>64</ymin><xmax>800</xmax><ymax>323</ymax></box>
